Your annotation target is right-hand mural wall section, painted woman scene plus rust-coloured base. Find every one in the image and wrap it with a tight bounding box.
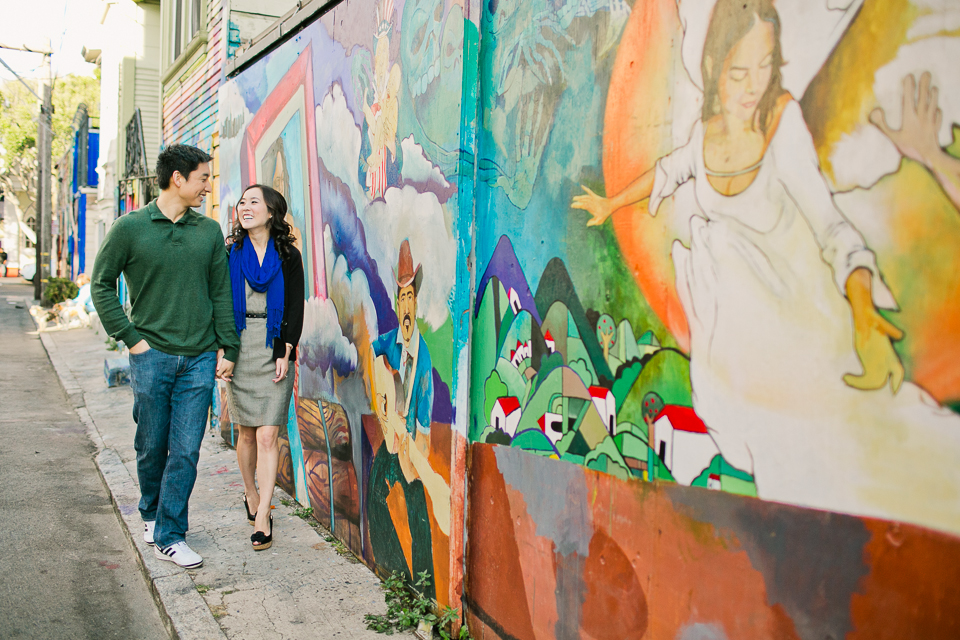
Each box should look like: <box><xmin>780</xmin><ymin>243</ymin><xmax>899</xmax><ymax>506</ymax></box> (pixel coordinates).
<box><xmin>466</xmin><ymin>0</ymin><xmax>960</xmax><ymax>640</ymax></box>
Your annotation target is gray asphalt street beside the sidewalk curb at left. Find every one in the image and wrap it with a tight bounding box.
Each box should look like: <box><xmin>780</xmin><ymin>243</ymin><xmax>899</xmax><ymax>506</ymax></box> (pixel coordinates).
<box><xmin>0</xmin><ymin>278</ymin><xmax>169</xmax><ymax>639</ymax></box>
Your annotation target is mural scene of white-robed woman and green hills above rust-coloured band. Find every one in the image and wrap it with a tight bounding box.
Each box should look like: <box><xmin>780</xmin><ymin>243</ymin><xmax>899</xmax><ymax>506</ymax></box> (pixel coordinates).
<box><xmin>470</xmin><ymin>0</ymin><xmax>960</xmax><ymax>533</ymax></box>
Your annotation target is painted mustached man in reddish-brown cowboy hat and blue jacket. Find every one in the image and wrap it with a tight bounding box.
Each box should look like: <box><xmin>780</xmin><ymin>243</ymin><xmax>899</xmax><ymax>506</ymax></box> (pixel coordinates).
<box><xmin>373</xmin><ymin>240</ymin><xmax>433</xmax><ymax>437</ymax></box>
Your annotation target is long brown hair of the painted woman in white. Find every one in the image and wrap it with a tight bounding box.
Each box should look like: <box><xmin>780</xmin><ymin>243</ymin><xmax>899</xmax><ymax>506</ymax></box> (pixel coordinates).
<box><xmin>700</xmin><ymin>0</ymin><xmax>784</xmax><ymax>133</ymax></box>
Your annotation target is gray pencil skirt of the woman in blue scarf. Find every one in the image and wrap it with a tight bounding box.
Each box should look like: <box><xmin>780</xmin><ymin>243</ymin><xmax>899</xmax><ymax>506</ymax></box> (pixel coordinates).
<box><xmin>227</xmin><ymin>318</ymin><xmax>294</xmax><ymax>427</ymax></box>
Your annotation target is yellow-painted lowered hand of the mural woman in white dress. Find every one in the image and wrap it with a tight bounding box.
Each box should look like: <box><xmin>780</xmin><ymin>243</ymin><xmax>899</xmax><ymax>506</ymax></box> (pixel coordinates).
<box><xmin>843</xmin><ymin>307</ymin><xmax>904</xmax><ymax>393</ymax></box>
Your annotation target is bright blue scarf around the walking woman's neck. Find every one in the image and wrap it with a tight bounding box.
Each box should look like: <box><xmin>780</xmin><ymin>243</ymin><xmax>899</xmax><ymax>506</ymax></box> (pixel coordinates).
<box><xmin>230</xmin><ymin>238</ymin><xmax>283</xmax><ymax>349</ymax></box>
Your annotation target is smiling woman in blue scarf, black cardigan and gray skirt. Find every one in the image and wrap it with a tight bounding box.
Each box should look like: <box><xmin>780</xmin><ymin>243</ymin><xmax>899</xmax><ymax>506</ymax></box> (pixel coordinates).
<box><xmin>221</xmin><ymin>184</ymin><xmax>304</xmax><ymax>551</ymax></box>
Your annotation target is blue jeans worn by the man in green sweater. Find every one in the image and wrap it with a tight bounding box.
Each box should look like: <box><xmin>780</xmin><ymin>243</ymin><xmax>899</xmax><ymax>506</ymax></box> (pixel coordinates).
<box><xmin>130</xmin><ymin>349</ymin><xmax>217</xmax><ymax>547</ymax></box>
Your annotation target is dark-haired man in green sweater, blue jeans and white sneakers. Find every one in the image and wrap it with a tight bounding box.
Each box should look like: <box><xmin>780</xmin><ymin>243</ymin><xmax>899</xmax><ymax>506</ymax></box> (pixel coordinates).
<box><xmin>91</xmin><ymin>145</ymin><xmax>240</xmax><ymax>569</ymax></box>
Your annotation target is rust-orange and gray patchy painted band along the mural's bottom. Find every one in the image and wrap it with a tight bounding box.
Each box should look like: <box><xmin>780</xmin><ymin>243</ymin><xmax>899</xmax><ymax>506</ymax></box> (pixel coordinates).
<box><xmin>464</xmin><ymin>444</ymin><xmax>960</xmax><ymax>640</ymax></box>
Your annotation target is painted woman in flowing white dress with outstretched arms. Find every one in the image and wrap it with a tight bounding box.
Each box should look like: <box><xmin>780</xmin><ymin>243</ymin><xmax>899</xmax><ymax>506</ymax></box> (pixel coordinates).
<box><xmin>572</xmin><ymin>0</ymin><xmax>960</xmax><ymax>533</ymax></box>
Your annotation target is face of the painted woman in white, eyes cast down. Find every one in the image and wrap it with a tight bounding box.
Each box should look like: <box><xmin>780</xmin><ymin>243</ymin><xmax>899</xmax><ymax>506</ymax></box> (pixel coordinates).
<box><xmin>717</xmin><ymin>17</ymin><xmax>776</xmax><ymax>123</ymax></box>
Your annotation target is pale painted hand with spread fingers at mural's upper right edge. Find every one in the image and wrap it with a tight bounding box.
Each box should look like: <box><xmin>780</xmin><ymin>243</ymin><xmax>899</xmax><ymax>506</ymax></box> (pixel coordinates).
<box><xmin>870</xmin><ymin>72</ymin><xmax>944</xmax><ymax>168</ymax></box>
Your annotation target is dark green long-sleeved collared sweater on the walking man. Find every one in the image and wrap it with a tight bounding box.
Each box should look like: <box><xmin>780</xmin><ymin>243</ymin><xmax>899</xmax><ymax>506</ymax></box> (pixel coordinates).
<box><xmin>90</xmin><ymin>200</ymin><xmax>240</xmax><ymax>362</ymax></box>
